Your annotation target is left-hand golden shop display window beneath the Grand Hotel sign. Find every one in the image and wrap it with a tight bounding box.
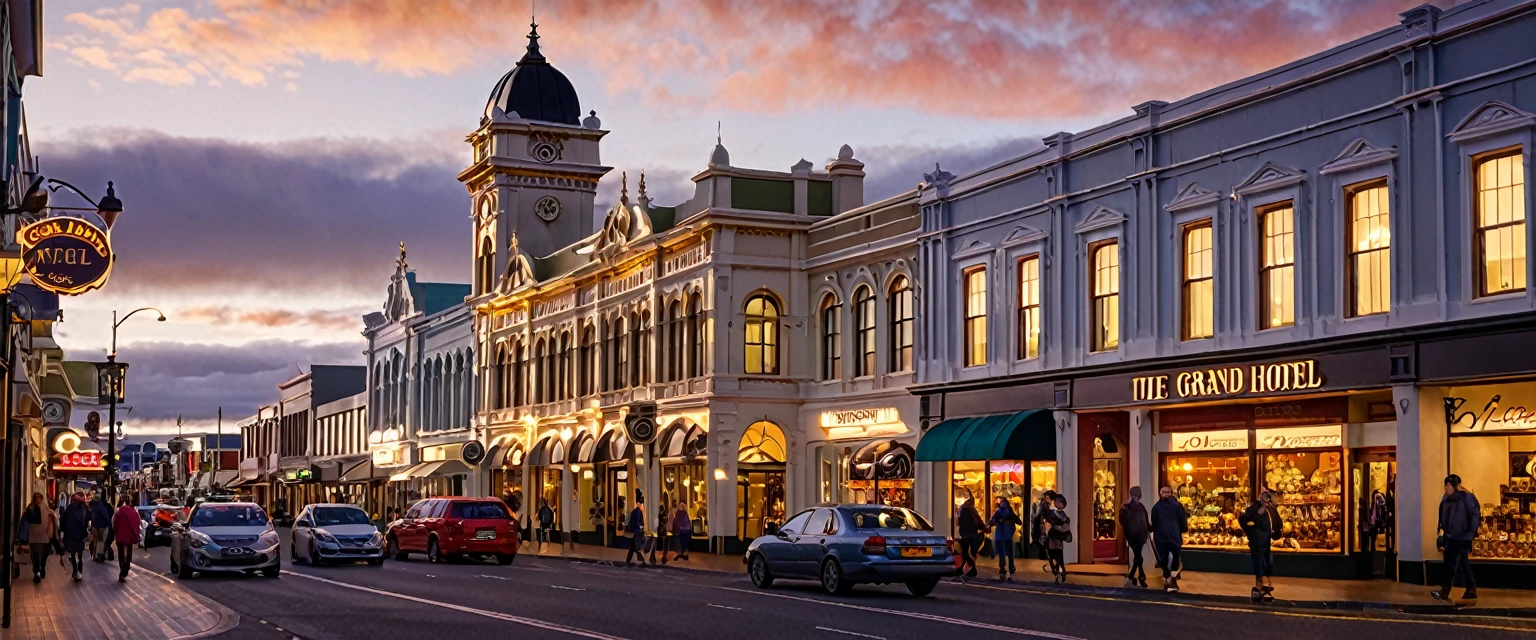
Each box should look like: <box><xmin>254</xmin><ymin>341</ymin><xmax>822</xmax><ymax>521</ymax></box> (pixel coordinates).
<box><xmin>1163</xmin><ymin>451</ymin><xmax>1253</xmax><ymax>549</ymax></box>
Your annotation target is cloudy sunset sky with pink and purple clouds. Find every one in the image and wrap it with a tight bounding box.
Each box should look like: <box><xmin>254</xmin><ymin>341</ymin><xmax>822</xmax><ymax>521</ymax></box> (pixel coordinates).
<box><xmin>25</xmin><ymin>0</ymin><xmax>1444</xmax><ymax>434</ymax></box>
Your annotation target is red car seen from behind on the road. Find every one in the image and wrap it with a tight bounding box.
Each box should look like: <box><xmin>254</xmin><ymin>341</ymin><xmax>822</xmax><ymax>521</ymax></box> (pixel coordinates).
<box><xmin>384</xmin><ymin>497</ymin><xmax>518</xmax><ymax>565</ymax></box>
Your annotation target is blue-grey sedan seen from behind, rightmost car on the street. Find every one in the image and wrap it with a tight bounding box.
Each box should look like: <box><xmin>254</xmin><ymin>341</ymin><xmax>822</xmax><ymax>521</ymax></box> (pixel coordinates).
<box><xmin>743</xmin><ymin>505</ymin><xmax>957</xmax><ymax>595</ymax></box>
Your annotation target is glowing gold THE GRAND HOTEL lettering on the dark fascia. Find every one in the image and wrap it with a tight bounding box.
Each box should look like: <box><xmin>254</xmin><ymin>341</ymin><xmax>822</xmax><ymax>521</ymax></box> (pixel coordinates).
<box><xmin>1130</xmin><ymin>361</ymin><xmax>1324</xmax><ymax>402</ymax></box>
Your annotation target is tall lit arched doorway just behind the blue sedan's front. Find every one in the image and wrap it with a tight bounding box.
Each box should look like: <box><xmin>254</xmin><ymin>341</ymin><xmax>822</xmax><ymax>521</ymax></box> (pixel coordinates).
<box><xmin>736</xmin><ymin>421</ymin><xmax>786</xmax><ymax>542</ymax></box>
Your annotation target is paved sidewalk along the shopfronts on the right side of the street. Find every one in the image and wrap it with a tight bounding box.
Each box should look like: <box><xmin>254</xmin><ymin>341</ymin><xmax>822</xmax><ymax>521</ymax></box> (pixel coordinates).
<box><xmin>524</xmin><ymin>543</ymin><xmax>1536</xmax><ymax>617</ymax></box>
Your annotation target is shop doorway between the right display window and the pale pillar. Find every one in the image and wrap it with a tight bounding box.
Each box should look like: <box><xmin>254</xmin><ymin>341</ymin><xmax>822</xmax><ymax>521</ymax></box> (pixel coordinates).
<box><xmin>1349</xmin><ymin>447</ymin><xmax>1398</xmax><ymax>580</ymax></box>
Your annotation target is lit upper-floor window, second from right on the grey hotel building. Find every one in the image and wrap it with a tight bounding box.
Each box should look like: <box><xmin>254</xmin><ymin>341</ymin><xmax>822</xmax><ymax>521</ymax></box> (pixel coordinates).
<box><xmin>1346</xmin><ymin>183</ymin><xmax>1392</xmax><ymax>316</ymax></box>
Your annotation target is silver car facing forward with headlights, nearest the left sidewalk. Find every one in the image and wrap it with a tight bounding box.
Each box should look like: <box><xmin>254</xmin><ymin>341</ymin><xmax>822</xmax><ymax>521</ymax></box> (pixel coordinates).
<box><xmin>170</xmin><ymin>502</ymin><xmax>283</xmax><ymax>579</ymax></box>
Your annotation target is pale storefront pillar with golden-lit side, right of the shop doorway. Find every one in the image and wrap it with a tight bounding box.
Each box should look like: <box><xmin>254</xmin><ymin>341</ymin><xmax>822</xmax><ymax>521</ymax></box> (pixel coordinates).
<box><xmin>1392</xmin><ymin>385</ymin><xmax>1450</xmax><ymax>585</ymax></box>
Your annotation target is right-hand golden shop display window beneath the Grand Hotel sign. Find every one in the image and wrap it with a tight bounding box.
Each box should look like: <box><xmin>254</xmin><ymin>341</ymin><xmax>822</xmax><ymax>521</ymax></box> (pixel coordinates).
<box><xmin>1260</xmin><ymin>451</ymin><xmax>1344</xmax><ymax>551</ymax></box>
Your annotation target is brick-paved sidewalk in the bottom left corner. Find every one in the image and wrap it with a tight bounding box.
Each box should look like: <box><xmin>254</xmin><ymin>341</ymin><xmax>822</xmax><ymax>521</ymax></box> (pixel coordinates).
<box><xmin>0</xmin><ymin>556</ymin><xmax>240</xmax><ymax>640</ymax></box>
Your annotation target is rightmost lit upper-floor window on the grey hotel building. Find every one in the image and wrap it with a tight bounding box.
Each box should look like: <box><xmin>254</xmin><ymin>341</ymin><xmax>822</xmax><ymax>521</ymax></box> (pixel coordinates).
<box><xmin>1475</xmin><ymin>149</ymin><xmax>1525</xmax><ymax>296</ymax></box>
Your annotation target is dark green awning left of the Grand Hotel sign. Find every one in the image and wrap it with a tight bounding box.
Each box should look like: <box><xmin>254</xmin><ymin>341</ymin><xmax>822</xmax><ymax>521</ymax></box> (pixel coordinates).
<box><xmin>917</xmin><ymin>408</ymin><xmax>1055</xmax><ymax>462</ymax></box>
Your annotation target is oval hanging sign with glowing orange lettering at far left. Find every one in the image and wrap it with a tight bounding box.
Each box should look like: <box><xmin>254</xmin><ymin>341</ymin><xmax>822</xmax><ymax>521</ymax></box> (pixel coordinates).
<box><xmin>20</xmin><ymin>216</ymin><xmax>112</xmax><ymax>296</ymax></box>
